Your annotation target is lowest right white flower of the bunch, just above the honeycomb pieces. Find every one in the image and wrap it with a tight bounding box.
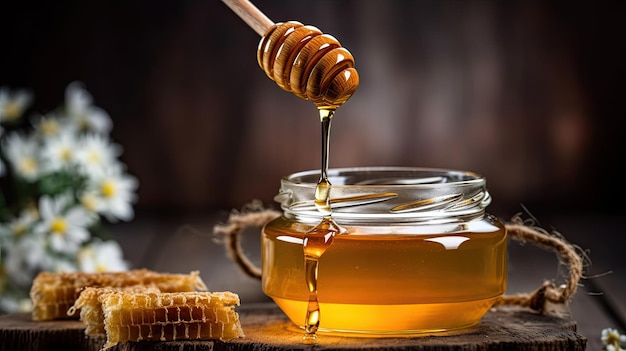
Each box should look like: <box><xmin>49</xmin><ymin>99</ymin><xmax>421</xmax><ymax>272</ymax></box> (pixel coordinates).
<box><xmin>78</xmin><ymin>239</ymin><xmax>128</xmax><ymax>273</ymax></box>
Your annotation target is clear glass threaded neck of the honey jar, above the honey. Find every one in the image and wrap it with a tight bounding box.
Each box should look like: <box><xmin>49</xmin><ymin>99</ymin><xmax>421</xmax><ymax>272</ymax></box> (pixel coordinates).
<box><xmin>275</xmin><ymin>167</ymin><xmax>491</xmax><ymax>224</ymax></box>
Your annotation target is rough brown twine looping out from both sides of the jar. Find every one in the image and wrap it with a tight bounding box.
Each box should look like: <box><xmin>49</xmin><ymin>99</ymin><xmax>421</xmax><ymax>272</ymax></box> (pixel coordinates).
<box><xmin>213</xmin><ymin>201</ymin><xmax>588</xmax><ymax>313</ymax></box>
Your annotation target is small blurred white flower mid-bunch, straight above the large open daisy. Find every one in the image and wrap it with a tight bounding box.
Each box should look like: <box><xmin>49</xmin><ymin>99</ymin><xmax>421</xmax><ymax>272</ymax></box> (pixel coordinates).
<box><xmin>41</xmin><ymin>129</ymin><xmax>78</xmax><ymax>172</ymax></box>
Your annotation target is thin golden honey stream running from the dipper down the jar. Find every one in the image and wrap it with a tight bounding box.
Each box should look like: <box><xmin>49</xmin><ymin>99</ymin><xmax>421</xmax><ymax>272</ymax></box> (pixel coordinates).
<box><xmin>302</xmin><ymin>109</ymin><xmax>342</xmax><ymax>344</ymax></box>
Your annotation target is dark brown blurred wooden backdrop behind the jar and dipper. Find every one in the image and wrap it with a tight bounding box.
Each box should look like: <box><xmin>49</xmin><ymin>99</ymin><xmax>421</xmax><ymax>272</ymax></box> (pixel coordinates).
<box><xmin>0</xmin><ymin>0</ymin><xmax>626</xmax><ymax>217</ymax></box>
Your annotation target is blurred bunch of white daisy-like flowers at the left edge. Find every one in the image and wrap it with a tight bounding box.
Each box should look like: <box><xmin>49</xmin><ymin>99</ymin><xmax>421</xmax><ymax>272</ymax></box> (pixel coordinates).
<box><xmin>0</xmin><ymin>82</ymin><xmax>138</xmax><ymax>312</ymax></box>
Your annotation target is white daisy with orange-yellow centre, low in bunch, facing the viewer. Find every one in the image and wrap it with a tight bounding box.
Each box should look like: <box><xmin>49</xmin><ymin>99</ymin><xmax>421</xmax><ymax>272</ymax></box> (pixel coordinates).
<box><xmin>35</xmin><ymin>196</ymin><xmax>94</xmax><ymax>254</ymax></box>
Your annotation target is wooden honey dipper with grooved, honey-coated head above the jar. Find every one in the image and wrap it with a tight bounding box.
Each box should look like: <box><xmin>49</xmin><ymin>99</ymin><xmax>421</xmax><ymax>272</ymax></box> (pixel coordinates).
<box><xmin>223</xmin><ymin>0</ymin><xmax>359</xmax><ymax>110</ymax></box>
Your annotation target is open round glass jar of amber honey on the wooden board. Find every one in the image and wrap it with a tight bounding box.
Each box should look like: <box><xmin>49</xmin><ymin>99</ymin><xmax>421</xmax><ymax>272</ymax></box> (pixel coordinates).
<box><xmin>261</xmin><ymin>167</ymin><xmax>507</xmax><ymax>336</ymax></box>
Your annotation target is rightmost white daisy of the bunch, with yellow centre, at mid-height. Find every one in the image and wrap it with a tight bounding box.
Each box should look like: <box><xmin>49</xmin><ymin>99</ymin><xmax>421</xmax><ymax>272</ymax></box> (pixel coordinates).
<box><xmin>81</xmin><ymin>167</ymin><xmax>138</xmax><ymax>222</ymax></box>
